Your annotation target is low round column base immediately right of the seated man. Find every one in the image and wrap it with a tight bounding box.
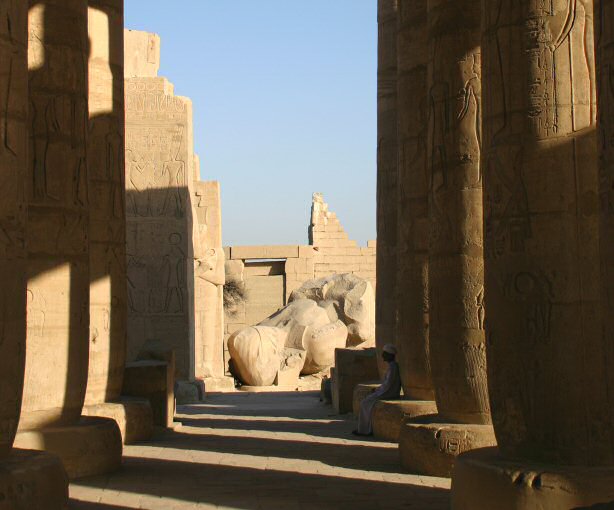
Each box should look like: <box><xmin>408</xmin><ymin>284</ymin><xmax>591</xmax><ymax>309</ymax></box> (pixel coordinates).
<box><xmin>373</xmin><ymin>400</ymin><xmax>437</xmax><ymax>443</ymax></box>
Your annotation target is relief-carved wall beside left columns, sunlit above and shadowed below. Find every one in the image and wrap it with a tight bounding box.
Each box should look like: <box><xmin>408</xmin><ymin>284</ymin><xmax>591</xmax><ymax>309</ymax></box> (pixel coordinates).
<box><xmin>126</xmin><ymin>31</ymin><xmax>195</xmax><ymax>380</ymax></box>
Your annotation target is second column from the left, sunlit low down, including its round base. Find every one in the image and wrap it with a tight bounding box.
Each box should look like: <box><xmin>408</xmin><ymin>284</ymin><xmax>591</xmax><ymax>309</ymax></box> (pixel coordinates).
<box><xmin>15</xmin><ymin>0</ymin><xmax>121</xmax><ymax>477</ymax></box>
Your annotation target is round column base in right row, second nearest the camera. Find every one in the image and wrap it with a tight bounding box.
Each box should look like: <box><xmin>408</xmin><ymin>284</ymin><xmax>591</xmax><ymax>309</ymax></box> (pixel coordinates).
<box><xmin>399</xmin><ymin>415</ymin><xmax>497</xmax><ymax>478</ymax></box>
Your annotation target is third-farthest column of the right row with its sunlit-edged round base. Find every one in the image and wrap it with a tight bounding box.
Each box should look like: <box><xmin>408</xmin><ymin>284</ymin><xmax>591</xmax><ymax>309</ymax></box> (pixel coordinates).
<box><xmin>402</xmin><ymin>0</ymin><xmax>495</xmax><ymax>476</ymax></box>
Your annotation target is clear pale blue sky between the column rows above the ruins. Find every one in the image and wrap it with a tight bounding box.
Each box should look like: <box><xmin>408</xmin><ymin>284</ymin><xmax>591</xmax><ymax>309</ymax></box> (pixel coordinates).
<box><xmin>125</xmin><ymin>0</ymin><xmax>377</xmax><ymax>245</ymax></box>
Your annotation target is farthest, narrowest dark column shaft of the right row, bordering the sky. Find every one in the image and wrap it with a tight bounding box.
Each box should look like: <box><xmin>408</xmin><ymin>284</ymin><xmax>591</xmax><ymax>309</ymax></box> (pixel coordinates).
<box><xmin>375</xmin><ymin>0</ymin><xmax>398</xmax><ymax>375</ymax></box>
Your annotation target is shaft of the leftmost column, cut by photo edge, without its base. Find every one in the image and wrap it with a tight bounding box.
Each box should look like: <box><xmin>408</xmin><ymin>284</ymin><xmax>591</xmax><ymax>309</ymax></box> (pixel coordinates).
<box><xmin>0</xmin><ymin>0</ymin><xmax>28</xmax><ymax>458</ymax></box>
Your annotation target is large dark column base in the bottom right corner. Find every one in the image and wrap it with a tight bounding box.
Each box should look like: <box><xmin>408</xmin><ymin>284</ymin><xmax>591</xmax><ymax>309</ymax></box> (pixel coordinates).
<box><xmin>452</xmin><ymin>448</ymin><xmax>614</xmax><ymax>510</ymax></box>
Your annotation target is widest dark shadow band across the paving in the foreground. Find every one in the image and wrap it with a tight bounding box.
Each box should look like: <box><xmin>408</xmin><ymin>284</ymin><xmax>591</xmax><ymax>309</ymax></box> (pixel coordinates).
<box><xmin>76</xmin><ymin>458</ymin><xmax>448</xmax><ymax>510</ymax></box>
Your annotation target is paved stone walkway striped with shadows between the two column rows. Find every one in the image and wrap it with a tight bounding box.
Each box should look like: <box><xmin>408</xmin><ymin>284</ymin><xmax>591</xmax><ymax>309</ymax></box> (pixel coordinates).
<box><xmin>70</xmin><ymin>392</ymin><xmax>450</xmax><ymax>510</ymax></box>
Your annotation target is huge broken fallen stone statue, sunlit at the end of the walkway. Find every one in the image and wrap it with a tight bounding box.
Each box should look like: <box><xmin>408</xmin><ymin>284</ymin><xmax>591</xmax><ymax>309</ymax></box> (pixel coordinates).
<box><xmin>228</xmin><ymin>274</ymin><xmax>375</xmax><ymax>386</ymax></box>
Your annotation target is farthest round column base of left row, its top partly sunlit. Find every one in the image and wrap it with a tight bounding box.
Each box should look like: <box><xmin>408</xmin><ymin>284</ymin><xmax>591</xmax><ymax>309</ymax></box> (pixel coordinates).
<box><xmin>82</xmin><ymin>397</ymin><xmax>153</xmax><ymax>444</ymax></box>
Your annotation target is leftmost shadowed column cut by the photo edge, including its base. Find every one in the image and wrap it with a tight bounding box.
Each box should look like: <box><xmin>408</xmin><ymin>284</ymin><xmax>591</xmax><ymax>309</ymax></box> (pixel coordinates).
<box><xmin>0</xmin><ymin>0</ymin><xmax>68</xmax><ymax>510</ymax></box>
